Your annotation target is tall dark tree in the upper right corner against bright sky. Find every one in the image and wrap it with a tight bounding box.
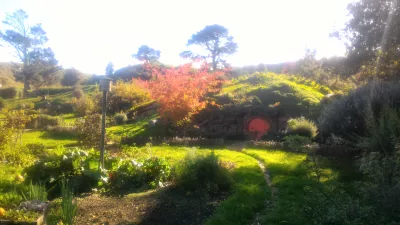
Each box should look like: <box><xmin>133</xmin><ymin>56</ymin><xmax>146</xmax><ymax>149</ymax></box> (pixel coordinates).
<box><xmin>334</xmin><ymin>0</ymin><xmax>400</xmax><ymax>78</ymax></box>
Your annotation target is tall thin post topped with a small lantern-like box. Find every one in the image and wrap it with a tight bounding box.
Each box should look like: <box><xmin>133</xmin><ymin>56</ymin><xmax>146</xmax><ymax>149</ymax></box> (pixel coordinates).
<box><xmin>99</xmin><ymin>77</ymin><xmax>112</xmax><ymax>168</ymax></box>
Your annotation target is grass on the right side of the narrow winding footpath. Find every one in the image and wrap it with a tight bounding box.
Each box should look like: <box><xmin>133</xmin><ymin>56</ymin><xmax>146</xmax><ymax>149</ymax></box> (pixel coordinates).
<box><xmin>244</xmin><ymin>150</ymin><xmax>337</xmax><ymax>225</ymax></box>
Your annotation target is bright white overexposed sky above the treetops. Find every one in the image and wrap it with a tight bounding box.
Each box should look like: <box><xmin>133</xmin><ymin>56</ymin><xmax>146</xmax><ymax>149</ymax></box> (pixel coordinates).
<box><xmin>0</xmin><ymin>0</ymin><xmax>350</xmax><ymax>74</ymax></box>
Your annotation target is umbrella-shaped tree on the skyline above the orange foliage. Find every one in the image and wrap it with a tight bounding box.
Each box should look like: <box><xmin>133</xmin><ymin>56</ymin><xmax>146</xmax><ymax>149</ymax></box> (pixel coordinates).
<box><xmin>180</xmin><ymin>24</ymin><xmax>238</xmax><ymax>71</ymax></box>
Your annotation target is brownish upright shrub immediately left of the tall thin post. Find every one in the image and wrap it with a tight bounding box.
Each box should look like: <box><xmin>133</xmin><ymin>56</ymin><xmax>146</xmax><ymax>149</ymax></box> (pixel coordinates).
<box><xmin>75</xmin><ymin>114</ymin><xmax>101</xmax><ymax>147</ymax></box>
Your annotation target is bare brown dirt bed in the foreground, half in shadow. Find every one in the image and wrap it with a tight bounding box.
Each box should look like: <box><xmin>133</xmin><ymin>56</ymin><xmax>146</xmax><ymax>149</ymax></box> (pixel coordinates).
<box><xmin>77</xmin><ymin>188</ymin><xmax>226</xmax><ymax>225</ymax></box>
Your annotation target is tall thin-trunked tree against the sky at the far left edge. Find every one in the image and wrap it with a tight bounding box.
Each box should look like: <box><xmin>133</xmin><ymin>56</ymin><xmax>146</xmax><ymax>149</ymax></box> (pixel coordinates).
<box><xmin>0</xmin><ymin>9</ymin><xmax>52</xmax><ymax>91</ymax></box>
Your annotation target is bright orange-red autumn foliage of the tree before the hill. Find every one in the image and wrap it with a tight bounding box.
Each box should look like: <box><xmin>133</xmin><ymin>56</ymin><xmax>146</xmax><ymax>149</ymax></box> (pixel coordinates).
<box><xmin>138</xmin><ymin>63</ymin><xmax>223</xmax><ymax>122</ymax></box>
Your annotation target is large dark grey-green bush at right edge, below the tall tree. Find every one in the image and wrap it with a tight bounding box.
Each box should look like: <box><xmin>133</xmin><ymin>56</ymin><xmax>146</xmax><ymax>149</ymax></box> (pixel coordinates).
<box><xmin>318</xmin><ymin>82</ymin><xmax>400</xmax><ymax>145</ymax></box>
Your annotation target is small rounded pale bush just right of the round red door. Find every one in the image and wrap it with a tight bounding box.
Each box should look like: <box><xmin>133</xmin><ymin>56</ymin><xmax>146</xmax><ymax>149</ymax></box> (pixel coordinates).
<box><xmin>287</xmin><ymin>117</ymin><xmax>317</xmax><ymax>139</ymax></box>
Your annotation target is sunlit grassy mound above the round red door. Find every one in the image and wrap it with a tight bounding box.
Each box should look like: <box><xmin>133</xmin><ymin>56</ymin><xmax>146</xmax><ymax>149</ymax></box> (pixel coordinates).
<box><xmin>221</xmin><ymin>73</ymin><xmax>332</xmax><ymax>118</ymax></box>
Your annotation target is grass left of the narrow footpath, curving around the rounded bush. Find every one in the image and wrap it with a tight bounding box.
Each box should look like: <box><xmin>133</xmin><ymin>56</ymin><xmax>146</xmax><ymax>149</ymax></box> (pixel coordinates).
<box><xmin>122</xmin><ymin>146</ymin><xmax>270</xmax><ymax>225</ymax></box>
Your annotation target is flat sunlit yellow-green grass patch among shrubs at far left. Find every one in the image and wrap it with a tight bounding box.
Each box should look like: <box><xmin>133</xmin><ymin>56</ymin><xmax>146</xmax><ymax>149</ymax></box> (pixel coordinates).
<box><xmin>22</xmin><ymin>131</ymin><xmax>77</xmax><ymax>148</ymax></box>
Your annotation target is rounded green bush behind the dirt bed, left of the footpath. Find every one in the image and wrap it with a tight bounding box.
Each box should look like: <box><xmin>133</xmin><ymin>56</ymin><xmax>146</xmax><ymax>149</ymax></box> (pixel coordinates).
<box><xmin>176</xmin><ymin>151</ymin><xmax>232</xmax><ymax>194</ymax></box>
